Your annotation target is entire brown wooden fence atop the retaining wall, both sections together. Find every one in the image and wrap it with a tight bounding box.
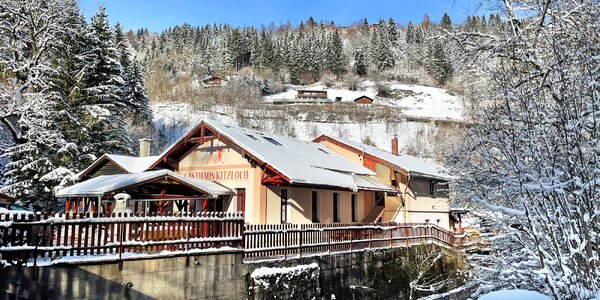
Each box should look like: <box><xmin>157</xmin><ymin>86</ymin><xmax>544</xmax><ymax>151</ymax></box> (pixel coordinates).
<box><xmin>0</xmin><ymin>212</ymin><xmax>478</xmax><ymax>266</ymax></box>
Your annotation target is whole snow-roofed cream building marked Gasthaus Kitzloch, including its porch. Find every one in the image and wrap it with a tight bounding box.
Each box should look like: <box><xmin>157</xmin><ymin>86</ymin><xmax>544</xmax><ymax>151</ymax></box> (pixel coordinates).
<box><xmin>57</xmin><ymin>120</ymin><xmax>450</xmax><ymax>228</ymax></box>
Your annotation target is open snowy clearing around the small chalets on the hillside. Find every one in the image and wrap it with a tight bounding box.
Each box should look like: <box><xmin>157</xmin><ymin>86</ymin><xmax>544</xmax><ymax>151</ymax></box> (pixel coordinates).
<box><xmin>263</xmin><ymin>81</ymin><xmax>464</xmax><ymax>121</ymax></box>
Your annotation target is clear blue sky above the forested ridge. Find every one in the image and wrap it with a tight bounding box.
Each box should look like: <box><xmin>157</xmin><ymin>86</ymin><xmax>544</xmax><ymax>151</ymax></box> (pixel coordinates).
<box><xmin>79</xmin><ymin>0</ymin><xmax>481</xmax><ymax>31</ymax></box>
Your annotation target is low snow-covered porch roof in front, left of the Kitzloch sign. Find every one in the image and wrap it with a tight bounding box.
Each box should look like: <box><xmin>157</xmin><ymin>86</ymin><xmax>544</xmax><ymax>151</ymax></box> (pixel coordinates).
<box><xmin>56</xmin><ymin>170</ymin><xmax>231</xmax><ymax>197</ymax></box>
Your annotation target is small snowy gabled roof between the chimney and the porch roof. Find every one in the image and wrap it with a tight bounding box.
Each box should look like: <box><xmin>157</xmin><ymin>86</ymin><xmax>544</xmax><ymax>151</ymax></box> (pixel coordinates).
<box><xmin>77</xmin><ymin>154</ymin><xmax>158</xmax><ymax>179</ymax></box>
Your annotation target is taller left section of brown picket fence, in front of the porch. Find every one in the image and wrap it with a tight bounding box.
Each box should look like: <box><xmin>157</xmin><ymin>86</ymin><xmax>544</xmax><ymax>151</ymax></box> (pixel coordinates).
<box><xmin>0</xmin><ymin>212</ymin><xmax>244</xmax><ymax>264</ymax></box>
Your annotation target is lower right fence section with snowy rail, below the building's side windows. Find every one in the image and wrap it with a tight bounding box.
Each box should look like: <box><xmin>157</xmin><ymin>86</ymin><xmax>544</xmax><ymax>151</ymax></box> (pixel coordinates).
<box><xmin>244</xmin><ymin>223</ymin><xmax>474</xmax><ymax>260</ymax></box>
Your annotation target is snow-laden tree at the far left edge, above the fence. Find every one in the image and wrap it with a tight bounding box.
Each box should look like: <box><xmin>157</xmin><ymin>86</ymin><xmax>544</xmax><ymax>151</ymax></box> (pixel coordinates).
<box><xmin>0</xmin><ymin>0</ymin><xmax>78</xmax><ymax>208</ymax></box>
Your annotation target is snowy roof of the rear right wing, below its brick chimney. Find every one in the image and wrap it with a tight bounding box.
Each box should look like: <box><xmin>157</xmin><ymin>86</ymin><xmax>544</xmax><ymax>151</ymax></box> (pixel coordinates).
<box><xmin>314</xmin><ymin>134</ymin><xmax>452</xmax><ymax>181</ymax></box>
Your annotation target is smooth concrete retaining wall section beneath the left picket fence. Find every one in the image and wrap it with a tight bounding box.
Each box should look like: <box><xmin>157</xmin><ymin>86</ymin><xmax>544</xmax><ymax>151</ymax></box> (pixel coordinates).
<box><xmin>0</xmin><ymin>253</ymin><xmax>248</xmax><ymax>300</ymax></box>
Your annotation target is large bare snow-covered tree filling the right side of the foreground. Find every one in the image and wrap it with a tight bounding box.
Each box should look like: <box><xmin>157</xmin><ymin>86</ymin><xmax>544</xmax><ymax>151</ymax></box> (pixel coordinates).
<box><xmin>455</xmin><ymin>0</ymin><xmax>600</xmax><ymax>299</ymax></box>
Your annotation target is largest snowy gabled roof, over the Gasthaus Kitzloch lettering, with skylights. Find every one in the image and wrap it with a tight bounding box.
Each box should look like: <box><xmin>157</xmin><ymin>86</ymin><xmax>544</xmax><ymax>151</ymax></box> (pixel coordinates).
<box><xmin>153</xmin><ymin>120</ymin><xmax>389</xmax><ymax>190</ymax></box>
